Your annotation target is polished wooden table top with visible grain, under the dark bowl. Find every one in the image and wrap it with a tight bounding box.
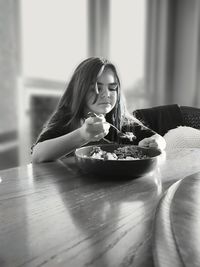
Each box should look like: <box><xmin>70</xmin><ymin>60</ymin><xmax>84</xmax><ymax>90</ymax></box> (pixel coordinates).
<box><xmin>0</xmin><ymin>149</ymin><xmax>200</xmax><ymax>267</ymax></box>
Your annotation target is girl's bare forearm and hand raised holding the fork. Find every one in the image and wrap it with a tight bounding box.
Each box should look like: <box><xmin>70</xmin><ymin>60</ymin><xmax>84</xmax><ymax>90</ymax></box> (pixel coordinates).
<box><xmin>32</xmin><ymin>118</ymin><xmax>109</xmax><ymax>163</ymax></box>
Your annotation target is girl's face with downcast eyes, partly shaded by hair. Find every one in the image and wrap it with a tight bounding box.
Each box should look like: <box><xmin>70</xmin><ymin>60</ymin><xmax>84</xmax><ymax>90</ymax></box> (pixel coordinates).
<box><xmin>85</xmin><ymin>68</ymin><xmax>118</xmax><ymax>114</ymax></box>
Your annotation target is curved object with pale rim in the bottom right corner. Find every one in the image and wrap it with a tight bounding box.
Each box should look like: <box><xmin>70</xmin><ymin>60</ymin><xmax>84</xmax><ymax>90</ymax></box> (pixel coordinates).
<box><xmin>153</xmin><ymin>172</ymin><xmax>200</xmax><ymax>267</ymax></box>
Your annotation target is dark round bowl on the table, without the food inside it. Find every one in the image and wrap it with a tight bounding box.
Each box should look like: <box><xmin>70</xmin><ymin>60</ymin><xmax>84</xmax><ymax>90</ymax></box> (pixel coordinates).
<box><xmin>75</xmin><ymin>144</ymin><xmax>162</xmax><ymax>178</ymax></box>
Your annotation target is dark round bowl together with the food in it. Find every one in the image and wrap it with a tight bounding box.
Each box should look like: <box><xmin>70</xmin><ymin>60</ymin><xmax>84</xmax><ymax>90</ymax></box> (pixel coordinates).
<box><xmin>75</xmin><ymin>144</ymin><xmax>162</xmax><ymax>179</ymax></box>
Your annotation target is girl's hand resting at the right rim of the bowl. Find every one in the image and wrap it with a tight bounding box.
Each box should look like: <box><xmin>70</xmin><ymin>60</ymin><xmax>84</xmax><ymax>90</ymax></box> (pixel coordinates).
<box><xmin>138</xmin><ymin>134</ymin><xmax>166</xmax><ymax>150</ymax></box>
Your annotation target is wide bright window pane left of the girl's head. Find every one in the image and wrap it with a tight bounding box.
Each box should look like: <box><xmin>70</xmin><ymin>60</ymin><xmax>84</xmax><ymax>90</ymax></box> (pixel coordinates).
<box><xmin>21</xmin><ymin>0</ymin><xmax>87</xmax><ymax>81</ymax></box>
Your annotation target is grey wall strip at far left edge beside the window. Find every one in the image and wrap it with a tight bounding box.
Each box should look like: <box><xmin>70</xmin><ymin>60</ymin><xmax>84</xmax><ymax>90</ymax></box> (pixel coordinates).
<box><xmin>0</xmin><ymin>0</ymin><xmax>17</xmax><ymax>136</ymax></box>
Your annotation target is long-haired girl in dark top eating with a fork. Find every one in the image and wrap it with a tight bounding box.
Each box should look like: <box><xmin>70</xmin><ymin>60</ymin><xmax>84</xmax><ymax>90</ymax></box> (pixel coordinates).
<box><xmin>32</xmin><ymin>57</ymin><xmax>165</xmax><ymax>163</ymax></box>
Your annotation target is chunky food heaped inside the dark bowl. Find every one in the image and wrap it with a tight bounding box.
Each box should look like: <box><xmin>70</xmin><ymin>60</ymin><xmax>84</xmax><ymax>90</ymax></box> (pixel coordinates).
<box><xmin>89</xmin><ymin>146</ymin><xmax>147</xmax><ymax>160</ymax></box>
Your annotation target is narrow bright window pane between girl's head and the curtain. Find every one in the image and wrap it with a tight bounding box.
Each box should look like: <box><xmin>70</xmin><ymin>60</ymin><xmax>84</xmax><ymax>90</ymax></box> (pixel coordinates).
<box><xmin>110</xmin><ymin>0</ymin><xmax>146</xmax><ymax>111</ymax></box>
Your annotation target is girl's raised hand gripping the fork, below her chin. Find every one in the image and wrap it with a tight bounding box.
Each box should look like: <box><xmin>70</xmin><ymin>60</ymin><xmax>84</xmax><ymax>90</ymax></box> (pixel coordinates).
<box><xmin>80</xmin><ymin>115</ymin><xmax>110</xmax><ymax>142</ymax></box>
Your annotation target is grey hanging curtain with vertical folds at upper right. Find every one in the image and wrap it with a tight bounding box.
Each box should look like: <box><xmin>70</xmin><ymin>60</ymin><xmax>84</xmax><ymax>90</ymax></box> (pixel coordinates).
<box><xmin>146</xmin><ymin>0</ymin><xmax>200</xmax><ymax>107</ymax></box>
